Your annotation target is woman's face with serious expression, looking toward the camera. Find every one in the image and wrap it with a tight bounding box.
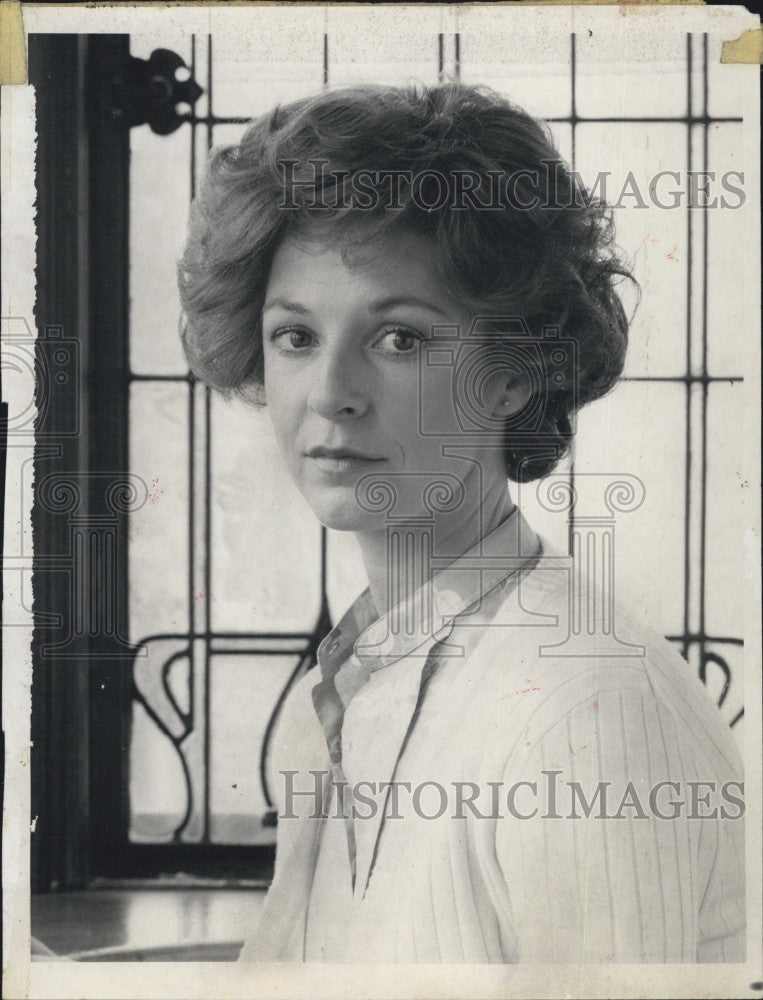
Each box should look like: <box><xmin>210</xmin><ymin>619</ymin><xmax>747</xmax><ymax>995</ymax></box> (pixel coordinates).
<box><xmin>262</xmin><ymin>227</ymin><xmax>506</xmax><ymax>531</ymax></box>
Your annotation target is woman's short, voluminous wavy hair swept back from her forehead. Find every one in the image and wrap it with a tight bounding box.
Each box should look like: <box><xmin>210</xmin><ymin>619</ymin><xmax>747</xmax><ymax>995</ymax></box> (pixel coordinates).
<box><xmin>178</xmin><ymin>82</ymin><xmax>633</xmax><ymax>482</ymax></box>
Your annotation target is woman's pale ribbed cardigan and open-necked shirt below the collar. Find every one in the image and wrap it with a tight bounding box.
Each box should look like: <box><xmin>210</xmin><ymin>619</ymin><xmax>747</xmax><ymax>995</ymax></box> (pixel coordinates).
<box><xmin>241</xmin><ymin>524</ymin><xmax>745</xmax><ymax>964</ymax></box>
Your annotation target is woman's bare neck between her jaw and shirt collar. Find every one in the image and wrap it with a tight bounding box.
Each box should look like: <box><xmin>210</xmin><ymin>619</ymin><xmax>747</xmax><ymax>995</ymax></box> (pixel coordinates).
<box><xmin>356</xmin><ymin>478</ymin><xmax>516</xmax><ymax>616</ymax></box>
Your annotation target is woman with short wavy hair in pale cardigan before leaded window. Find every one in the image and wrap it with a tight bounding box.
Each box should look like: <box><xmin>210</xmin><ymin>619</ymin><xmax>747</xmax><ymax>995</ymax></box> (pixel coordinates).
<box><xmin>180</xmin><ymin>84</ymin><xmax>744</xmax><ymax>963</ymax></box>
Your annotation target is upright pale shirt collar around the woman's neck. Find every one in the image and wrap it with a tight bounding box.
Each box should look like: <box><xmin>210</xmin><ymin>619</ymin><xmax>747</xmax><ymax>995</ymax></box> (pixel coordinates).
<box><xmin>317</xmin><ymin>507</ymin><xmax>540</xmax><ymax>677</ymax></box>
